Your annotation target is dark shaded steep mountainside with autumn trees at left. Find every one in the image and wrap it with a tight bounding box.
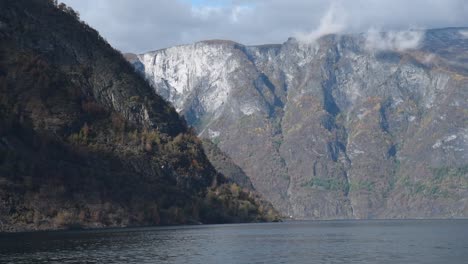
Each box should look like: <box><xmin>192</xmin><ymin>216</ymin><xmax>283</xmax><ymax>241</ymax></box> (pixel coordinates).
<box><xmin>0</xmin><ymin>0</ymin><xmax>277</xmax><ymax>231</ymax></box>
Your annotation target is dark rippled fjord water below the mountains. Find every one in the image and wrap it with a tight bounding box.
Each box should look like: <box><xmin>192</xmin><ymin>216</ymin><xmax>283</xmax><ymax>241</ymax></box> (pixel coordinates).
<box><xmin>0</xmin><ymin>220</ymin><xmax>468</xmax><ymax>263</ymax></box>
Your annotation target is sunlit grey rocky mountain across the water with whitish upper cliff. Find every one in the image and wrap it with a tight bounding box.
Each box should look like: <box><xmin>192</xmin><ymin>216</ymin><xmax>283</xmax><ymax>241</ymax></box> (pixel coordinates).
<box><xmin>134</xmin><ymin>28</ymin><xmax>468</xmax><ymax>219</ymax></box>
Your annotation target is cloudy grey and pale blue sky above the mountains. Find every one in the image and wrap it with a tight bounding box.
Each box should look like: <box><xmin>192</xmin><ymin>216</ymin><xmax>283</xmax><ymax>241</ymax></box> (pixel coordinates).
<box><xmin>62</xmin><ymin>0</ymin><xmax>468</xmax><ymax>53</ymax></box>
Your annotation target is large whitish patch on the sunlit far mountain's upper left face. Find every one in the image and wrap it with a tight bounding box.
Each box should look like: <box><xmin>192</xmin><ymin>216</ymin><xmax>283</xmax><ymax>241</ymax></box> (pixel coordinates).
<box><xmin>139</xmin><ymin>42</ymin><xmax>239</xmax><ymax>112</ymax></box>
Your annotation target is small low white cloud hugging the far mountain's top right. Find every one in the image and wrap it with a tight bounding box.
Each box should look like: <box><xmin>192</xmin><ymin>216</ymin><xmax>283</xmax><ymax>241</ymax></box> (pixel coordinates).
<box><xmin>366</xmin><ymin>29</ymin><xmax>424</xmax><ymax>51</ymax></box>
